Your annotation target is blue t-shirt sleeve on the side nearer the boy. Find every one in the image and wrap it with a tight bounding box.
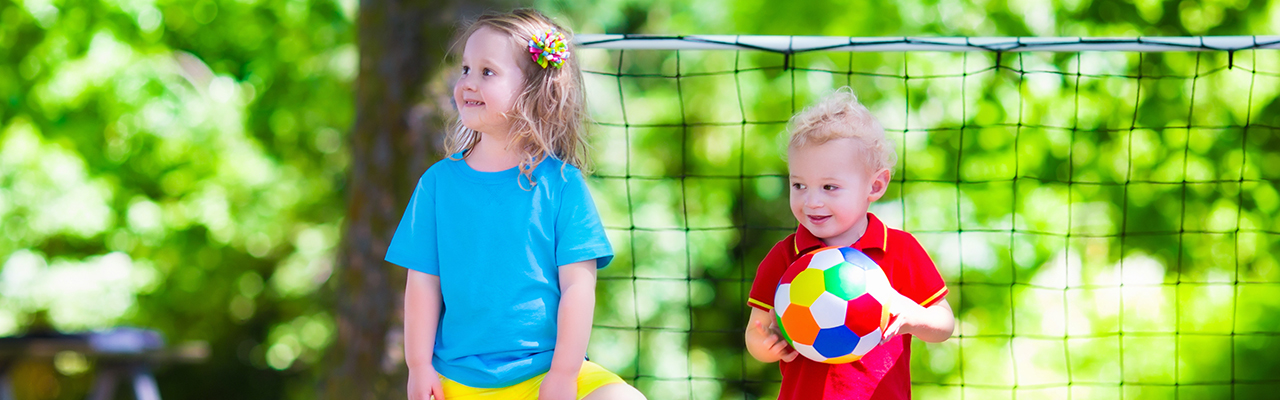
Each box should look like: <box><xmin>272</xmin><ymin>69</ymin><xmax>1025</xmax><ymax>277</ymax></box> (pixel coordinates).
<box><xmin>556</xmin><ymin>168</ymin><xmax>613</xmax><ymax>268</ymax></box>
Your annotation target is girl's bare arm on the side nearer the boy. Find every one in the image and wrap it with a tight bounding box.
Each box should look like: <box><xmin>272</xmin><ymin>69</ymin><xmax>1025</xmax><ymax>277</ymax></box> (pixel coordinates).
<box><xmin>539</xmin><ymin>259</ymin><xmax>595</xmax><ymax>399</ymax></box>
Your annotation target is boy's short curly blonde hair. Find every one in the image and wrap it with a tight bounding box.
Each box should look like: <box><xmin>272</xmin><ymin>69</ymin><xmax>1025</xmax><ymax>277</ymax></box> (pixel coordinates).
<box><xmin>787</xmin><ymin>86</ymin><xmax>897</xmax><ymax>174</ymax></box>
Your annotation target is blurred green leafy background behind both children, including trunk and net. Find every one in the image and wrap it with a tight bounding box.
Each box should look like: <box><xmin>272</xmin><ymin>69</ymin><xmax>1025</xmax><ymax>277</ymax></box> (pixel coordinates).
<box><xmin>0</xmin><ymin>0</ymin><xmax>1280</xmax><ymax>399</ymax></box>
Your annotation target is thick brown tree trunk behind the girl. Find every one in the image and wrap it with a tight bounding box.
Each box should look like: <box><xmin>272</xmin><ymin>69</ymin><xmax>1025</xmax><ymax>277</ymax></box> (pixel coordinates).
<box><xmin>319</xmin><ymin>0</ymin><xmax>503</xmax><ymax>399</ymax></box>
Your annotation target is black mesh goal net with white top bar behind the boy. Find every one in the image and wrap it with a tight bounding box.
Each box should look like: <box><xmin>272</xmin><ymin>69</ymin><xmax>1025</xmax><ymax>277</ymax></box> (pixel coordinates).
<box><xmin>576</xmin><ymin>35</ymin><xmax>1280</xmax><ymax>399</ymax></box>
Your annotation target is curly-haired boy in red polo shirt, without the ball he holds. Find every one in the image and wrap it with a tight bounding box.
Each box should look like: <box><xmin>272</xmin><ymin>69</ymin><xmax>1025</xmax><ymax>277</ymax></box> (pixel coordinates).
<box><xmin>746</xmin><ymin>87</ymin><xmax>955</xmax><ymax>400</ymax></box>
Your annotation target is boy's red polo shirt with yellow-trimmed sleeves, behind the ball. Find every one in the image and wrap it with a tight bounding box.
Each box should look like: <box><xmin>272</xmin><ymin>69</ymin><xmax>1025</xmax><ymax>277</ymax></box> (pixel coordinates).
<box><xmin>748</xmin><ymin>213</ymin><xmax>947</xmax><ymax>400</ymax></box>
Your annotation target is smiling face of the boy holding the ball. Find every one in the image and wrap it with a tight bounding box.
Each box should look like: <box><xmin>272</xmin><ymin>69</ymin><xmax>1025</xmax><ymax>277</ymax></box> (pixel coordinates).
<box><xmin>787</xmin><ymin>138</ymin><xmax>890</xmax><ymax>246</ymax></box>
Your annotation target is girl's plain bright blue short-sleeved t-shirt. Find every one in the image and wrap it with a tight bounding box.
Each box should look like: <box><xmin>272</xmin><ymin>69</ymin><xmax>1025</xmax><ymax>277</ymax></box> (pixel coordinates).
<box><xmin>387</xmin><ymin>153</ymin><xmax>613</xmax><ymax>387</ymax></box>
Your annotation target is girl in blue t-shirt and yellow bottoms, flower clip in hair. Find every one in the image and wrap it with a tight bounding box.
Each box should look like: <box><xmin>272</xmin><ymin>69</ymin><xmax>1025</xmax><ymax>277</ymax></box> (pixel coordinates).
<box><xmin>387</xmin><ymin>10</ymin><xmax>644</xmax><ymax>400</ymax></box>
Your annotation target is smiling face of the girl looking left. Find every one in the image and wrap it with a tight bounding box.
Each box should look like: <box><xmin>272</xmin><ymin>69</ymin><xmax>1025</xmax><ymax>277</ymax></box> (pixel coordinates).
<box><xmin>453</xmin><ymin>27</ymin><xmax>532</xmax><ymax>136</ymax></box>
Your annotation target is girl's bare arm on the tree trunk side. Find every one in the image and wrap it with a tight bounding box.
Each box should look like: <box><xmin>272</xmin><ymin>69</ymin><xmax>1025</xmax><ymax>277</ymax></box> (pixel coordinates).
<box><xmin>404</xmin><ymin>269</ymin><xmax>444</xmax><ymax>400</ymax></box>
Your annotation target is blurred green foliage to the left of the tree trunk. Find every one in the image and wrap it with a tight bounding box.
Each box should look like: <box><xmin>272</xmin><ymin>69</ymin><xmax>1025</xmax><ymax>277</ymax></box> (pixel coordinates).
<box><xmin>0</xmin><ymin>0</ymin><xmax>357</xmax><ymax>399</ymax></box>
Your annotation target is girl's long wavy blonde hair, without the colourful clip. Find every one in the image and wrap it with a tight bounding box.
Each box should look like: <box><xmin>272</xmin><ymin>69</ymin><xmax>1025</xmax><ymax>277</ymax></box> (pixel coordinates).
<box><xmin>444</xmin><ymin>9</ymin><xmax>590</xmax><ymax>185</ymax></box>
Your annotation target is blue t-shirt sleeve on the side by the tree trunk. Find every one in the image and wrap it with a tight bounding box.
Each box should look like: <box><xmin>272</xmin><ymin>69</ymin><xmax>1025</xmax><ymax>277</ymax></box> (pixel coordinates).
<box><xmin>387</xmin><ymin>171</ymin><xmax>440</xmax><ymax>276</ymax></box>
